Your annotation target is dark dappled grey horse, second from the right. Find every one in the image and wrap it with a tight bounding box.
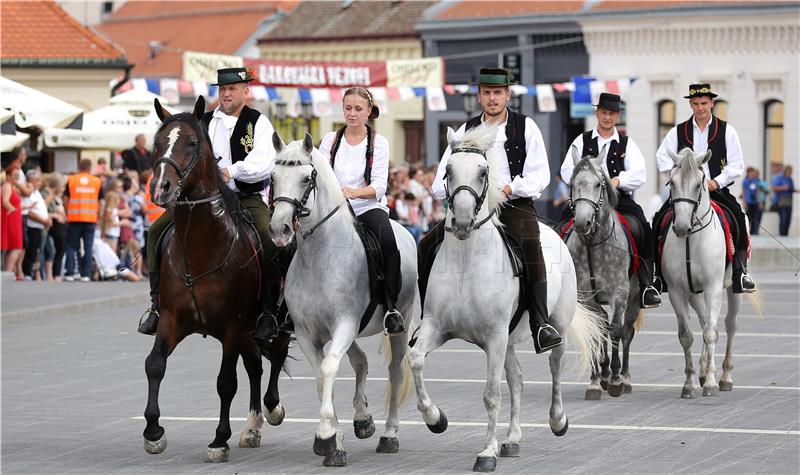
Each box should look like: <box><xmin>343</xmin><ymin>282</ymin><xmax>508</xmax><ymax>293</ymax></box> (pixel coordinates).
<box><xmin>567</xmin><ymin>156</ymin><xmax>641</xmax><ymax>400</ymax></box>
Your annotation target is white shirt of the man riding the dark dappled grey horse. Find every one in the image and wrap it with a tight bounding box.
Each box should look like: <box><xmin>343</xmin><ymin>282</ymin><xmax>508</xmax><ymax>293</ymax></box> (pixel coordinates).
<box><xmin>561</xmin><ymin>127</ymin><xmax>647</xmax><ymax>194</ymax></box>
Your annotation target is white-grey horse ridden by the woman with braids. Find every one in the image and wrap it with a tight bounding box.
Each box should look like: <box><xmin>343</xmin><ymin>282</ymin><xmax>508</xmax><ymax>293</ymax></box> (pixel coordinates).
<box><xmin>270</xmin><ymin>132</ymin><xmax>418</xmax><ymax>467</ymax></box>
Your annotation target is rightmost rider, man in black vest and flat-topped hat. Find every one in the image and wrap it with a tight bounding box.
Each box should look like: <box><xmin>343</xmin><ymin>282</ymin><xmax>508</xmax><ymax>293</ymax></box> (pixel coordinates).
<box><xmin>653</xmin><ymin>84</ymin><xmax>756</xmax><ymax>294</ymax></box>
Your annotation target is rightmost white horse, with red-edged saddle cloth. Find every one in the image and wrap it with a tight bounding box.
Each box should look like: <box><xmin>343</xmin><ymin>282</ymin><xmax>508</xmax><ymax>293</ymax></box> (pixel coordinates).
<box><xmin>661</xmin><ymin>148</ymin><xmax>762</xmax><ymax>399</ymax></box>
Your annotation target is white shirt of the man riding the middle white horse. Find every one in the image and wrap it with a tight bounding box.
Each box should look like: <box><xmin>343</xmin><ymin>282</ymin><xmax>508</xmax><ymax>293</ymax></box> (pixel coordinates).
<box><xmin>431</xmin><ymin>115</ymin><xmax>550</xmax><ymax>200</ymax></box>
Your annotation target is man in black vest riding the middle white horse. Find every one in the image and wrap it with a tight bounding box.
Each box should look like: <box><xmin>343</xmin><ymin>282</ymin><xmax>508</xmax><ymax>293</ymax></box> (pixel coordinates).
<box><xmin>417</xmin><ymin>68</ymin><xmax>561</xmax><ymax>353</ymax></box>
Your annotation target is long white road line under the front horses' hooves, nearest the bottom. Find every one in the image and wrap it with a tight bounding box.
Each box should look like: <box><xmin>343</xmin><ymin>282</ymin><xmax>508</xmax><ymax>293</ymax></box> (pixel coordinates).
<box><xmin>129</xmin><ymin>416</ymin><xmax>800</xmax><ymax>435</ymax></box>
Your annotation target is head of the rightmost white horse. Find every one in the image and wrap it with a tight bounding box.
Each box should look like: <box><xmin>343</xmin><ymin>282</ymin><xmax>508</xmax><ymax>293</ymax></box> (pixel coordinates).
<box><xmin>668</xmin><ymin>147</ymin><xmax>711</xmax><ymax>237</ymax></box>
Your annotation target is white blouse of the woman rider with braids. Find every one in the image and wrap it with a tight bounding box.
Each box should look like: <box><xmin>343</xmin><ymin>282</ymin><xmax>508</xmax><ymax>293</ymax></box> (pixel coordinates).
<box><xmin>319</xmin><ymin>132</ymin><xmax>389</xmax><ymax>216</ymax></box>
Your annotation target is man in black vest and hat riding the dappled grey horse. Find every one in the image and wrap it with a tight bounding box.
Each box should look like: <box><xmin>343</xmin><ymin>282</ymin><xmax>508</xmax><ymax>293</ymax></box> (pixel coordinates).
<box><xmin>561</xmin><ymin>92</ymin><xmax>661</xmax><ymax>308</ymax></box>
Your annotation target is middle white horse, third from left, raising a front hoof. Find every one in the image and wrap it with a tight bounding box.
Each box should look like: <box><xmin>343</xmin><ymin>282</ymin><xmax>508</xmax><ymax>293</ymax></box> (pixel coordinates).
<box><xmin>409</xmin><ymin>126</ymin><xmax>603</xmax><ymax>471</ymax></box>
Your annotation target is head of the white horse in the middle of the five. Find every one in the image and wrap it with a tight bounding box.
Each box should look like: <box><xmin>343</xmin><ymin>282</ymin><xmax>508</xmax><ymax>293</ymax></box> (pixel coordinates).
<box><xmin>445</xmin><ymin>125</ymin><xmax>503</xmax><ymax>240</ymax></box>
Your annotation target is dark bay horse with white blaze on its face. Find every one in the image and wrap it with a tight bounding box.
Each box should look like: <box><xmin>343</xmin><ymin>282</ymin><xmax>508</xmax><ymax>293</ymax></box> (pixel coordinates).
<box><xmin>144</xmin><ymin>97</ymin><xmax>289</xmax><ymax>462</ymax></box>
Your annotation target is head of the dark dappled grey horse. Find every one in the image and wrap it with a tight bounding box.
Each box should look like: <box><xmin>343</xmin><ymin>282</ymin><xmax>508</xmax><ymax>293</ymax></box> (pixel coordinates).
<box><xmin>570</xmin><ymin>150</ymin><xmax>619</xmax><ymax>236</ymax></box>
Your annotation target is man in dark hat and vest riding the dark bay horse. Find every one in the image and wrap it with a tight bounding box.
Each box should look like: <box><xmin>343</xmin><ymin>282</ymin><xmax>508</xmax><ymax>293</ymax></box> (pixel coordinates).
<box><xmin>139</xmin><ymin>68</ymin><xmax>283</xmax><ymax>338</ymax></box>
